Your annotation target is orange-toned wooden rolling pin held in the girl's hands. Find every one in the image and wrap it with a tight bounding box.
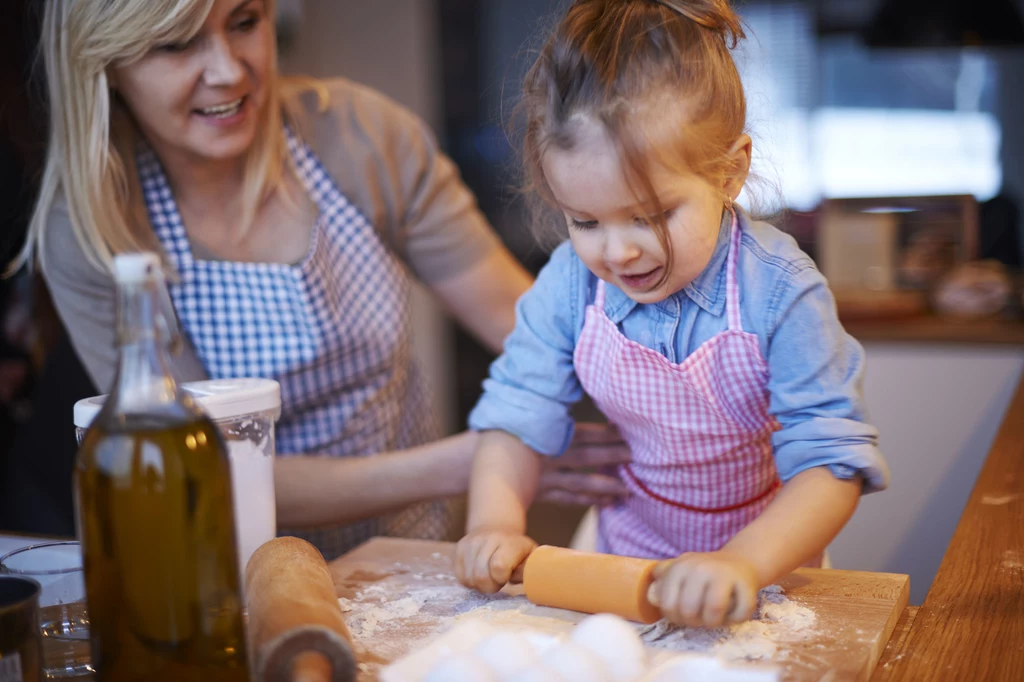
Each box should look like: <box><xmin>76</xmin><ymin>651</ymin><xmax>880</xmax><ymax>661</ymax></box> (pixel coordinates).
<box><xmin>522</xmin><ymin>546</ymin><xmax>662</xmax><ymax>623</ymax></box>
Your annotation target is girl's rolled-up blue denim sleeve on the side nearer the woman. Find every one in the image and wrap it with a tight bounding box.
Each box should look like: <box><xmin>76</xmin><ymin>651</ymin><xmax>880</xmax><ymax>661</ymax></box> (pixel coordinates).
<box><xmin>469</xmin><ymin>243</ymin><xmax>582</xmax><ymax>456</ymax></box>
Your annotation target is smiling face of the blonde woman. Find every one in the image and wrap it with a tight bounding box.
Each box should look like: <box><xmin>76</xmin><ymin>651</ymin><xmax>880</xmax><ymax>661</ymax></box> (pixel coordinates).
<box><xmin>111</xmin><ymin>0</ymin><xmax>275</xmax><ymax>168</ymax></box>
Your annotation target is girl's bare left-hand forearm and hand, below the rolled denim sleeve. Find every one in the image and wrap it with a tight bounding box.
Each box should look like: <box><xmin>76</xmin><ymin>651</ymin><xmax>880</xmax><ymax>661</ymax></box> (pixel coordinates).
<box><xmin>455</xmin><ymin>431</ymin><xmax>542</xmax><ymax>593</ymax></box>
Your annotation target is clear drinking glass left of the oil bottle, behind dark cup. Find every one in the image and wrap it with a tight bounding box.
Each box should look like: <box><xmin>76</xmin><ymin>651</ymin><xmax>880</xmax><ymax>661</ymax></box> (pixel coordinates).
<box><xmin>0</xmin><ymin>542</ymin><xmax>93</xmax><ymax>679</ymax></box>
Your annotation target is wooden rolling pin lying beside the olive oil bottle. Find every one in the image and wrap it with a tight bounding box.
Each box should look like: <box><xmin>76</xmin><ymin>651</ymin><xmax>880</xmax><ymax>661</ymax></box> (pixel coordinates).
<box><xmin>246</xmin><ymin>538</ymin><xmax>355</xmax><ymax>682</ymax></box>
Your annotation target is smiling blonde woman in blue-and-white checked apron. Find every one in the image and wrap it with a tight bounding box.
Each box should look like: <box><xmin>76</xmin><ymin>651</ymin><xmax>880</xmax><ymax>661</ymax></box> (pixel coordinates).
<box><xmin>19</xmin><ymin>0</ymin><xmax>623</xmax><ymax>557</ymax></box>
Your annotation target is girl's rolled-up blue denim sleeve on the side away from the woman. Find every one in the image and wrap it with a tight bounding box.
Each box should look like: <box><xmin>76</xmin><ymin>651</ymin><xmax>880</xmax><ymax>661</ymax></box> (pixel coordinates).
<box><xmin>768</xmin><ymin>265</ymin><xmax>889</xmax><ymax>494</ymax></box>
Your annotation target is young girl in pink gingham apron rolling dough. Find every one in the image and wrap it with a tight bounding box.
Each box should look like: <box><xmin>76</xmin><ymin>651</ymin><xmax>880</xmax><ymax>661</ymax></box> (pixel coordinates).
<box><xmin>456</xmin><ymin>0</ymin><xmax>888</xmax><ymax>627</ymax></box>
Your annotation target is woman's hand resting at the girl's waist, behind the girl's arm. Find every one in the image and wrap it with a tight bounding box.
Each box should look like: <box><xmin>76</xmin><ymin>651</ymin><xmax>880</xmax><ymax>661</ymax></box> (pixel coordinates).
<box><xmin>537</xmin><ymin>424</ymin><xmax>631</xmax><ymax>506</ymax></box>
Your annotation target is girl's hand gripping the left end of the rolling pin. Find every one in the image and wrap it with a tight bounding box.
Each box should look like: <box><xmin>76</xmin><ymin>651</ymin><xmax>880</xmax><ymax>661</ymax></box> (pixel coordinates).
<box><xmin>455</xmin><ymin>528</ymin><xmax>537</xmax><ymax>594</ymax></box>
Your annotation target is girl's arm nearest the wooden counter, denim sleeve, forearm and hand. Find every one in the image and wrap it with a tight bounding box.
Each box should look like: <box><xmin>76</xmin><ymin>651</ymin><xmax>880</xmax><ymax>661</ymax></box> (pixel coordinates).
<box><xmin>651</xmin><ymin>260</ymin><xmax>889</xmax><ymax>627</ymax></box>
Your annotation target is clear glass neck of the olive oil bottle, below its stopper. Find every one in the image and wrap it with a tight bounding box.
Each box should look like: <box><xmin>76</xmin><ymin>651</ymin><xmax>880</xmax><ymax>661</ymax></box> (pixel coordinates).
<box><xmin>111</xmin><ymin>280</ymin><xmax>178</xmax><ymax>414</ymax></box>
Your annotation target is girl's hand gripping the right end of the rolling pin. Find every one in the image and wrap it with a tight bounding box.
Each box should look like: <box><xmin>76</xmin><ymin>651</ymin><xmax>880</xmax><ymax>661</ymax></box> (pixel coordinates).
<box><xmin>647</xmin><ymin>551</ymin><xmax>759</xmax><ymax>628</ymax></box>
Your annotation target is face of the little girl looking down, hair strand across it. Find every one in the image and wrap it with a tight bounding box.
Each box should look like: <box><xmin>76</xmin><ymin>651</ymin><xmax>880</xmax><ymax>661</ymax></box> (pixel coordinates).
<box><xmin>543</xmin><ymin>120</ymin><xmax>750</xmax><ymax>303</ymax></box>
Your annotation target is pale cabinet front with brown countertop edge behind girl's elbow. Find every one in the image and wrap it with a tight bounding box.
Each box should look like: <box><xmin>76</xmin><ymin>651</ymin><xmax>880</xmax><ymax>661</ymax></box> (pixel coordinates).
<box><xmin>829</xmin><ymin>317</ymin><xmax>1024</xmax><ymax>602</ymax></box>
